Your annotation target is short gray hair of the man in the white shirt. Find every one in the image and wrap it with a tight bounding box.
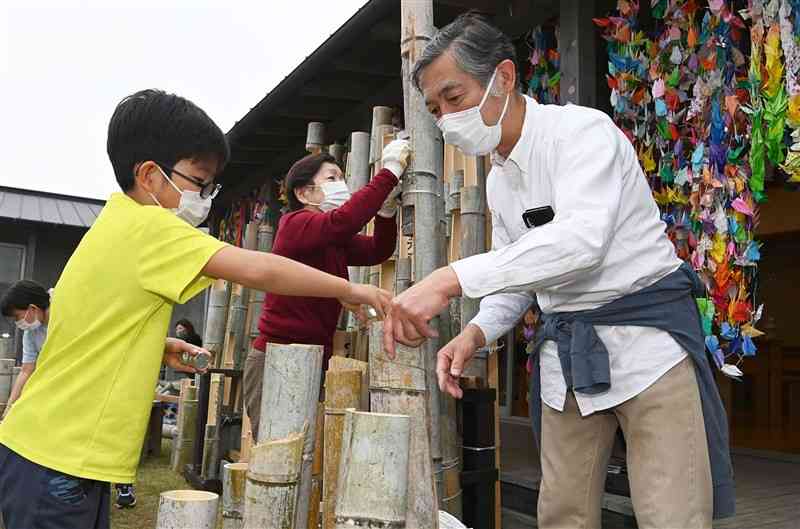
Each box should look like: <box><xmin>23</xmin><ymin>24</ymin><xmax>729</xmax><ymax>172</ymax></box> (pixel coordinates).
<box><xmin>412</xmin><ymin>12</ymin><xmax>516</xmax><ymax>90</ymax></box>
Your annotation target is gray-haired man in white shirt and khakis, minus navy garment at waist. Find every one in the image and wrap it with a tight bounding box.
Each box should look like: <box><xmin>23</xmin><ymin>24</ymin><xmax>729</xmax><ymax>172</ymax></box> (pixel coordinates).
<box><xmin>384</xmin><ymin>14</ymin><xmax>727</xmax><ymax>529</ymax></box>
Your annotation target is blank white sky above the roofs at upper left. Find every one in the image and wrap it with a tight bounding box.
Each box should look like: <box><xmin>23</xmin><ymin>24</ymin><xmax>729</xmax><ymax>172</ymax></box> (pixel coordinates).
<box><xmin>0</xmin><ymin>0</ymin><xmax>366</xmax><ymax>199</ymax></box>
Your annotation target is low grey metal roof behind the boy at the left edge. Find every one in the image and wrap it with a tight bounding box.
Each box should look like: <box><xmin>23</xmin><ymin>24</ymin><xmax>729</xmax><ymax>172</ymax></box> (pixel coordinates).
<box><xmin>0</xmin><ymin>186</ymin><xmax>105</xmax><ymax>228</ymax></box>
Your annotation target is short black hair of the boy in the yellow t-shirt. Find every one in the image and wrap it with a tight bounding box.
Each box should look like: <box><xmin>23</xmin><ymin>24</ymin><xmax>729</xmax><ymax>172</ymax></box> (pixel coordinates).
<box><xmin>106</xmin><ymin>89</ymin><xmax>230</xmax><ymax>192</ymax></box>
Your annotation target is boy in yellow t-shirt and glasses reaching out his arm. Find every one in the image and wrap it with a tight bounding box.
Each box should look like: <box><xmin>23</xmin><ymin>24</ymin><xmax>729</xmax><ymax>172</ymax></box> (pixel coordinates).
<box><xmin>0</xmin><ymin>90</ymin><xmax>390</xmax><ymax>529</ymax></box>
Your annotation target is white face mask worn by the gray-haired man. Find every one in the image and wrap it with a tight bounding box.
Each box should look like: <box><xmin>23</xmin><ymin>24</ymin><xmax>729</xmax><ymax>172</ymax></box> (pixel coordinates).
<box><xmin>436</xmin><ymin>68</ymin><xmax>511</xmax><ymax>156</ymax></box>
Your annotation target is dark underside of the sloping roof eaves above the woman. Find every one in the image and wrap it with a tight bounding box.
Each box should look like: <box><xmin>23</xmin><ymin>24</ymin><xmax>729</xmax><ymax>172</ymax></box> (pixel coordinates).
<box><xmin>214</xmin><ymin>0</ymin><xmax>559</xmax><ymax>209</ymax></box>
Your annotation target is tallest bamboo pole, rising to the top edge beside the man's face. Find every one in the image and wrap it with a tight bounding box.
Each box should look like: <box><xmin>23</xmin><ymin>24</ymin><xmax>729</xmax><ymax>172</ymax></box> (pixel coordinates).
<box><xmin>400</xmin><ymin>0</ymin><xmax>444</xmax><ymax>504</ymax></box>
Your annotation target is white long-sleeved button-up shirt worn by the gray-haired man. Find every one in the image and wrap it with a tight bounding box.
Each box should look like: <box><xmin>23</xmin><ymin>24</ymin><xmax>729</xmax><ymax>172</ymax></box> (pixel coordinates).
<box><xmin>452</xmin><ymin>96</ymin><xmax>686</xmax><ymax>415</ymax></box>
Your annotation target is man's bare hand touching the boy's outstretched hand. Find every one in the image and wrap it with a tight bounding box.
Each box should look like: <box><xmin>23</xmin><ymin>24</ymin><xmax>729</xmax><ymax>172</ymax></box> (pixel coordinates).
<box><xmin>383</xmin><ymin>267</ymin><xmax>461</xmax><ymax>358</ymax></box>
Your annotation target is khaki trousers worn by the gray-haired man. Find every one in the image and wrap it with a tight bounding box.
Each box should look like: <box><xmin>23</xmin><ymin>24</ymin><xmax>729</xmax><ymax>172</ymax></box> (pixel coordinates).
<box><xmin>537</xmin><ymin>358</ymin><xmax>713</xmax><ymax>529</ymax></box>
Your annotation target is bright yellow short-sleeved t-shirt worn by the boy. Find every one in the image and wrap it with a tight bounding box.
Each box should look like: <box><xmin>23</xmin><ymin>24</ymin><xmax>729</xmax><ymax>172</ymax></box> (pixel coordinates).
<box><xmin>0</xmin><ymin>193</ymin><xmax>225</xmax><ymax>483</ymax></box>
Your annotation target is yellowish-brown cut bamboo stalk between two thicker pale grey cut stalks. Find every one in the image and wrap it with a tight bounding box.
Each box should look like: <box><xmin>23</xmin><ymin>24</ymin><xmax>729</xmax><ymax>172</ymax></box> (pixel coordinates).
<box><xmin>322</xmin><ymin>369</ymin><xmax>363</xmax><ymax>529</ymax></box>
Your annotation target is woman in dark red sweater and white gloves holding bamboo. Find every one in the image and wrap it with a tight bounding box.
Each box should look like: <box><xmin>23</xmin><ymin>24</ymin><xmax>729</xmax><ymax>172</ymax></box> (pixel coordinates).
<box><xmin>244</xmin><ymin>140</ymin><xmax>410</xmax><ymax>440</ymax></box>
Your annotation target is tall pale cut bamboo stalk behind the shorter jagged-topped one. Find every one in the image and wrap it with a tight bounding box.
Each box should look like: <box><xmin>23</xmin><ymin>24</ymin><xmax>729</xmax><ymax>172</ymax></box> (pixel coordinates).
<box><xmin>253</xmin><ymin>343</ymin><xmax>323</xmax><ymax>528</ymax></box>
